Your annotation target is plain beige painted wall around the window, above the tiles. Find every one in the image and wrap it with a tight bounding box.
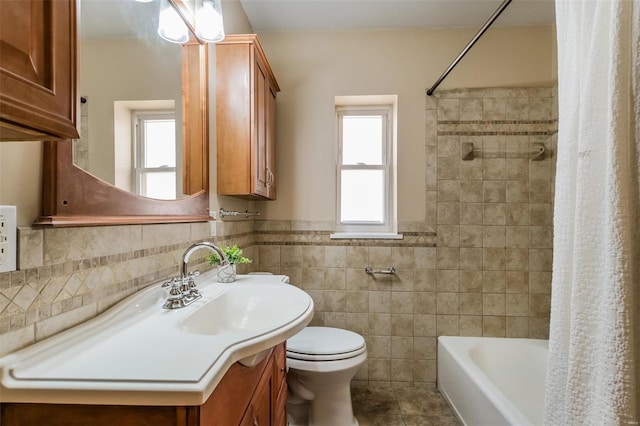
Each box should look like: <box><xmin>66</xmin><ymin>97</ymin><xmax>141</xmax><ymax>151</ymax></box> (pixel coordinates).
<box><xmin>257</xmin><ymin>27</ymin><xmax>556</xmax><ymax>222</ymax></box>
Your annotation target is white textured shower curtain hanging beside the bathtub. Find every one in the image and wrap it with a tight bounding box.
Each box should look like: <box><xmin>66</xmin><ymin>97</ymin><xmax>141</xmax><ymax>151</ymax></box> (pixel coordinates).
<box><xmin>544</xmin><ymin>0</ymin><xmax>640</xmax><ymax>426</ymax></box>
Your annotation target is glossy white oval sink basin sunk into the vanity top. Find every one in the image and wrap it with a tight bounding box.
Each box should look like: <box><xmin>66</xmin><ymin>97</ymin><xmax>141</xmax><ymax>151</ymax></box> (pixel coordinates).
<box><xmin>181</xmin><ymin>284</ymin><xmax>309</xmax><ymax>335</ymax></box>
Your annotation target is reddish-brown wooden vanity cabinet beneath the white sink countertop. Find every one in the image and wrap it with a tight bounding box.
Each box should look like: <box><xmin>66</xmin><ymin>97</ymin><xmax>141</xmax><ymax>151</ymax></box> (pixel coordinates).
<box><xmin>0</xmin><ymin>343</ymin><xmax>287</xmax><ymax>426</ymax></box>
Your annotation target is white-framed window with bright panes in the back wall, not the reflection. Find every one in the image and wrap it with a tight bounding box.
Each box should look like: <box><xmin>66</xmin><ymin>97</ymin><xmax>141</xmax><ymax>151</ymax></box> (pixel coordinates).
<box><xmin>332</xmin><ymin>100</ymin><xmax>396</xmax><ymax>238</ymax></box>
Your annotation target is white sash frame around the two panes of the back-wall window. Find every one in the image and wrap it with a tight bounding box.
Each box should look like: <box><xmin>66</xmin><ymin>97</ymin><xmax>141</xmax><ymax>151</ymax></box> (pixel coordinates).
<box><xmin>331</xmin><ymin>103</ymin><xmax>401</xmax><ymax>238</ymax></box>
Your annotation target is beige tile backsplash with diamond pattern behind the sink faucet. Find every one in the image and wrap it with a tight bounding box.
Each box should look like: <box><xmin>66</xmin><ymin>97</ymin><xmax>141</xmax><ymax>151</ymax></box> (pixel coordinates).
<box><xmin>0</xmin><ymin>222</ymin><xmax>257</xmax><ymax>355</ymax></box>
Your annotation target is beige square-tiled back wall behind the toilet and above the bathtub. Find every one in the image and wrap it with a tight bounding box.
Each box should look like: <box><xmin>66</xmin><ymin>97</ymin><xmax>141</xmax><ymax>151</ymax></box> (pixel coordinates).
<box><xmin>255</xmin><ymin>88</ymin><xmax>557</xmax><ymax>386</ymax></box>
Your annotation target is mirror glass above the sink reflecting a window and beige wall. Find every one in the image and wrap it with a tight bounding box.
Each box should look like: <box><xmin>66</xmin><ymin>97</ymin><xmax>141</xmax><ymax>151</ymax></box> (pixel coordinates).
<box><xmin>73</xmin><ymin>0</ymin><xmax>187</xmax><ymax>199</ymax></box>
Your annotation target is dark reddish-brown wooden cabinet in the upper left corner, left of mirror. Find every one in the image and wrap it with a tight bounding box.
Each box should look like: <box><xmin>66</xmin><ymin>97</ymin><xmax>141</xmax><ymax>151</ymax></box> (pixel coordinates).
<box><xmin>0</xmin><ymin>0</ymin><xmax>78</xmax><ymax>141</ymax></box>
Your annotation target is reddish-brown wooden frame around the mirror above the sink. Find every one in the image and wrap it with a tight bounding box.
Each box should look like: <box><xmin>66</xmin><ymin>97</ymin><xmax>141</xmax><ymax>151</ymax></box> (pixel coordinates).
<box><xmin>34</xmin><ymin>0</ymin><xmax>211</xmax><ymax>226</ymax></box>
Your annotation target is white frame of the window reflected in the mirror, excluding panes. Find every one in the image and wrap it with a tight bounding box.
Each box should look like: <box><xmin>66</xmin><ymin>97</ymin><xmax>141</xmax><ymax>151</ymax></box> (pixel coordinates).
<box><xmin>132</xmin><ymin>110</ymin><xmax>178</xmax><ymax>199</ymax></box>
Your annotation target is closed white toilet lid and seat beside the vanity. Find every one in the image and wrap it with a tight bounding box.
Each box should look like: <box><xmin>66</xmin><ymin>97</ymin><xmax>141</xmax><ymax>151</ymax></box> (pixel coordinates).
<box><xmin>287</xmin><ymin>327</ymin><xmax>366</xmax><ymax>360</ymax></box>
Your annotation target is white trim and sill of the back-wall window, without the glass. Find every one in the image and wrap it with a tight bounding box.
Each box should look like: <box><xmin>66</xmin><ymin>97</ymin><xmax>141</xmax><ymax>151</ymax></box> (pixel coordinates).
<box><xmin>330</xmin><ymin>96</ymin><xmax>403</xmax><ymax>239</ymax></box>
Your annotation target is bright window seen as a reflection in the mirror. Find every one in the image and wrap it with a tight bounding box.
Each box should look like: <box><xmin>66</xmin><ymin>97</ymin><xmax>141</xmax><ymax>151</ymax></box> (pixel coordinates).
<box><xmin>134</xmin><ymin>112</ymin><xmax>176</xmax><ymax>200</ymax></box>
